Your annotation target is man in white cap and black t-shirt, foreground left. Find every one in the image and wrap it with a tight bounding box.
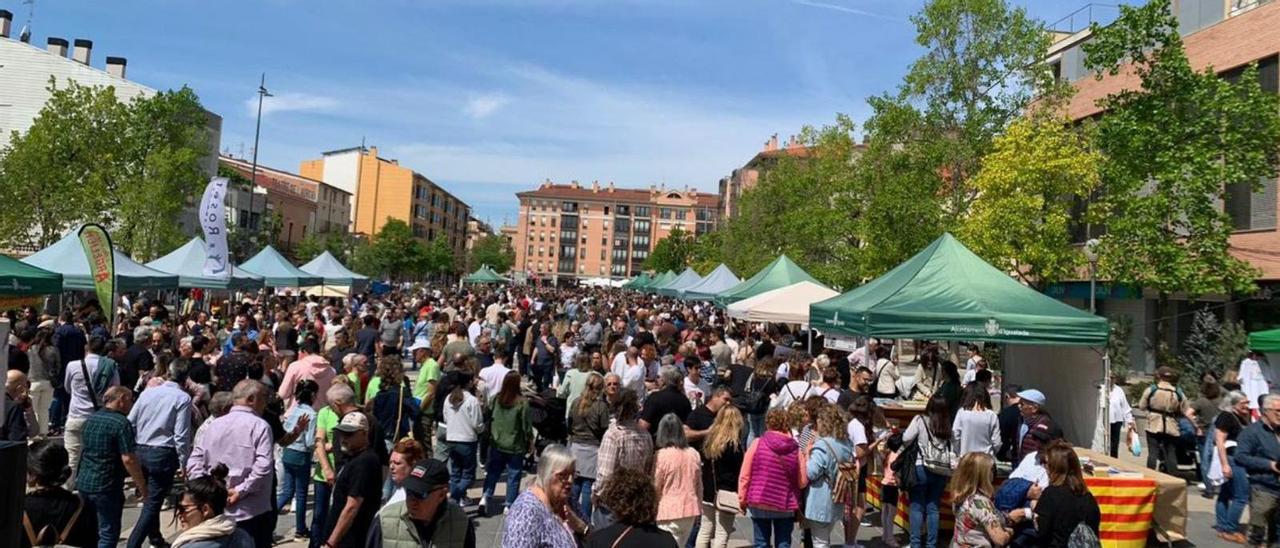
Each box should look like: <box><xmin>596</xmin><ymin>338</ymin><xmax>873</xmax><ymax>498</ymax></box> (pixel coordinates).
<box><xmin>321</xmin><ymin>411</ymin><xmax>383</xmax><ymax>548</ymax></box>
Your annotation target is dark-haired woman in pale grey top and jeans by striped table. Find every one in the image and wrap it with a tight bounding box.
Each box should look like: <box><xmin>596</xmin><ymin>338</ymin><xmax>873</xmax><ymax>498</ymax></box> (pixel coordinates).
<box><xmin>902</xmin><ymin>394</ymin><xmax>955</xmax><ymax>548</ymax></box>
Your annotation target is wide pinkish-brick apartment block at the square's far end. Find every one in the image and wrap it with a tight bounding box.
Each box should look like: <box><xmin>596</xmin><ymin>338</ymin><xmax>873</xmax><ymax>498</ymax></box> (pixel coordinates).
<box><xmin>514</xmin><ymin>181</ymin><xmax>719</xmax><ymax>282</ymax></box>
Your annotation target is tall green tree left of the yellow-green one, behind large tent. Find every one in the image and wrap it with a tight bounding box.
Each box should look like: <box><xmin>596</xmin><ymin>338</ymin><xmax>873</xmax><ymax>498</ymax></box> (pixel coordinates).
<box><xmin>855</xmin><ymin>0</ymin><xmax>1061</xmax><ymax>278</ymax></box>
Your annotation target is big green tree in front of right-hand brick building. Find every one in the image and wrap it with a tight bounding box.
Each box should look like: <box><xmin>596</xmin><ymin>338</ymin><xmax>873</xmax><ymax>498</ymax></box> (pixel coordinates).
<box><xmin>1084</xmin><ymin>0</ymin><xmax>1280</xmax><ymax>339</ymax></box>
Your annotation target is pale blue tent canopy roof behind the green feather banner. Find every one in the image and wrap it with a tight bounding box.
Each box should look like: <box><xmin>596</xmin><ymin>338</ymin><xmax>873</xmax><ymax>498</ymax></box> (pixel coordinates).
<box><xmin>22</xmin><ymin>227</ymin><xmax>178</xmax><ymax>293</ymax></box>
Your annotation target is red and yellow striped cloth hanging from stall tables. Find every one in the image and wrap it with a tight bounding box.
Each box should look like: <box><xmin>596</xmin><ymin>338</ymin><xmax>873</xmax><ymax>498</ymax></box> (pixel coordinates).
<box><xmin>867</xmin><ymin>476</ymin><xmax>1156</xmax><ymax>548</ymax></box>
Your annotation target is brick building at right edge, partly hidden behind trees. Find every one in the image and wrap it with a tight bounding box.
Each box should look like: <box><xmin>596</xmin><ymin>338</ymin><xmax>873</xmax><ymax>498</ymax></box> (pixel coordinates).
<box><xmin>1047</xmin><ymin>0</ymin><xmax>1280</xmax><ymax>369</ymax></box>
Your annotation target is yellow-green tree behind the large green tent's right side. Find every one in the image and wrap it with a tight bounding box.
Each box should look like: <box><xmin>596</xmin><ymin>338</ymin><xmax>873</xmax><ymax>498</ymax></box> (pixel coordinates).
<box><xmin>959</xmin><ymin>111</ymin><xmax>1102</xmax><ymax>287</ymax></box>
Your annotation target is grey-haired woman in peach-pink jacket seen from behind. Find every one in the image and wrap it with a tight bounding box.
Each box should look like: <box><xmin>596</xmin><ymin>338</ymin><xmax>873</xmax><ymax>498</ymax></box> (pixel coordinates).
<box><xmin>654</xmin><ymin>414</ymin><xmax>703</xmax><ymax>545</ymax></box>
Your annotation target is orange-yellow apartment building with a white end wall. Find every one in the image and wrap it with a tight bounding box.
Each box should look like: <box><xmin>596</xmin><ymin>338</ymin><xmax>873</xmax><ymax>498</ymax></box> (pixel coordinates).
<box><xmin>298</xmin><ymin>146</ymin><xmax>471</xmax><ymax>257</ymax></box>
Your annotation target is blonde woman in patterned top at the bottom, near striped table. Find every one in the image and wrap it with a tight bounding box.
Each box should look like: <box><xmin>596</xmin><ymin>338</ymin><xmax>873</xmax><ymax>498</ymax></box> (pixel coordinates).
<box><xmin>947</xmin><ymin>452</ymin><xmax>1024</xmax><ymax>547</ymax></box>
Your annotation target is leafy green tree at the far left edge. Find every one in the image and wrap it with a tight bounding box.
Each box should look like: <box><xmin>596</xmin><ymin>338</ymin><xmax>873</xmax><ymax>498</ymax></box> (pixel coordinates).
<box><xmin>0</xmin><ymin>78</ymin><xmax>127</xmax><ymax>247</ymax></box>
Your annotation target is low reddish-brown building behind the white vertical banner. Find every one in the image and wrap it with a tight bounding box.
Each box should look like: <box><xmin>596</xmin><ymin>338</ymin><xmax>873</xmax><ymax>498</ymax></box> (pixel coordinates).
<box><xmin>219</xmin><ymin>155</ymin><xmax>351</xmax><ymax>255</ymax></box>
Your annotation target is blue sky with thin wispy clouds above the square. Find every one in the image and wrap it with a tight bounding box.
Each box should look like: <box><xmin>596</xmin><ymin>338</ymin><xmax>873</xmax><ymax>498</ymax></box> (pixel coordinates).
<box><xmin>15</xmin><ymin>0</ymin><xmax>1085</xmax><ymax>225</ymax></box>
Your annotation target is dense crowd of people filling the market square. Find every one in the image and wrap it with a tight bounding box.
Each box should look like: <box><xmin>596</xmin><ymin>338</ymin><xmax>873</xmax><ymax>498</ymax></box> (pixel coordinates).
<box><xmin>4</xmin><ymin>282</ymin><xmax>1121</xmax><ymax>548</ymax></box>
